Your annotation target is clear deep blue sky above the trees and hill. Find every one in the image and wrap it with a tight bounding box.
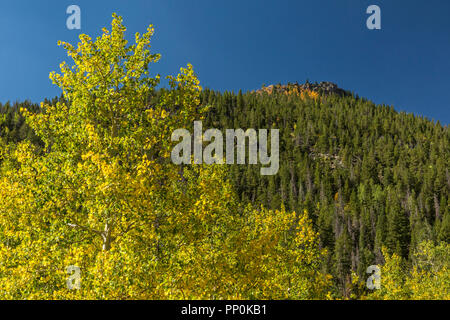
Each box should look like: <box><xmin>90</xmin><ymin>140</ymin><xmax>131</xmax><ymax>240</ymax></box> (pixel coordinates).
<box><xmin>0</xmin><ymin>0</ymin><xmax>450</xmax><ymax>124</ymax></box>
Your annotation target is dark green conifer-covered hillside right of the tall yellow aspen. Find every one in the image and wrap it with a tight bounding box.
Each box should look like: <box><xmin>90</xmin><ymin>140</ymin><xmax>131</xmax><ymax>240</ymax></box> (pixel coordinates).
<box><xmin>202</xmin><ymin>83</ymin><xmax>450</xmax><ymax>294</ymax></box>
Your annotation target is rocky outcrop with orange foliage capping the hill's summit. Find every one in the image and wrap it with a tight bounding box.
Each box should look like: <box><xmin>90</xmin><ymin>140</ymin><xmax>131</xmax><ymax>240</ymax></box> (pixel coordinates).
<box><xmin>256</xmin><ymin>81</ymin><xmax>351</xmax><ymax>96</ymax></box>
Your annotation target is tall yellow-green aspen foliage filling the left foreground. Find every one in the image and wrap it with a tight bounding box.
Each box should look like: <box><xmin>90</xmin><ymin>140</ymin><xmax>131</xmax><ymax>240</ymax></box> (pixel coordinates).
<box><xmin>0</xmin><ymin>15</ymin><xmax>330</xmax><ymax>299</ymax></box>
